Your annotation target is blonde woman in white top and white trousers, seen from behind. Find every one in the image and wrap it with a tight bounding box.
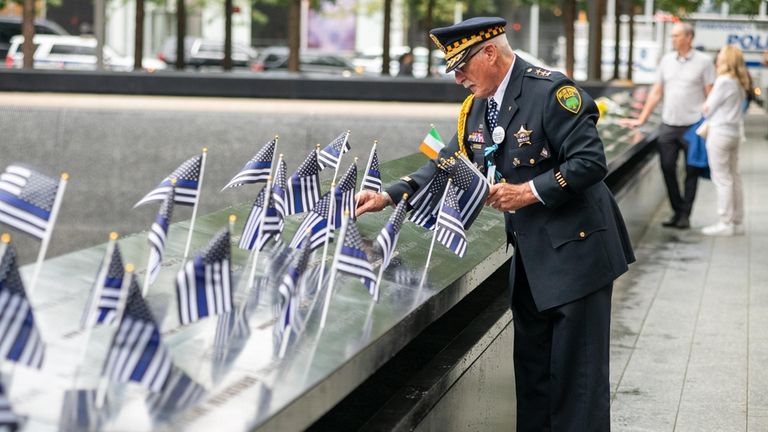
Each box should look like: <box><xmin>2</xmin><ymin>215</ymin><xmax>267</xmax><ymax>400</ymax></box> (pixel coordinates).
<box><xmin>702</xmin><ymin>45</ymin><xmax>749</xmax><ymax>236</ymax></box>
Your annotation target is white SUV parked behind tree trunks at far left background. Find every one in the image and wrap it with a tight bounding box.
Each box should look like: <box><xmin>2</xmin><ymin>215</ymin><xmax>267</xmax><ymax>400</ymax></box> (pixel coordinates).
<box><xmin>5</xmin><ymin>35</ymin><xmax>166</xmax><ymax>72</ymax></box>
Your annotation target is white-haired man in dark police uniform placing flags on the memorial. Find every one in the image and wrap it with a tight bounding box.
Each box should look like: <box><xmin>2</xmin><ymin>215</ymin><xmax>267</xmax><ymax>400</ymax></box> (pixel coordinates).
<box><xmin>357</xmin><ymin>18</ymin><xmax>634</xmax><ymax>431</ymax></box>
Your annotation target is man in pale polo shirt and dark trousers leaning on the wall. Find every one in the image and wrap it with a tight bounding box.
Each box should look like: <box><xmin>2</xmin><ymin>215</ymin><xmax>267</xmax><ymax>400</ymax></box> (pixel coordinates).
<box><xmin>625</xmin><ymin>23</ymin><xmax>715</xmax><ymax>229</ymax></box>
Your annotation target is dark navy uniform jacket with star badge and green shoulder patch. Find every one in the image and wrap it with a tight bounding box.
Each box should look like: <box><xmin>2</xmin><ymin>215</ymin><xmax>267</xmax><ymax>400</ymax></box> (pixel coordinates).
<box><xmin>387</xmin><ymin>57</ymin><xmax>635</xmax><ymax>310</ymax></box>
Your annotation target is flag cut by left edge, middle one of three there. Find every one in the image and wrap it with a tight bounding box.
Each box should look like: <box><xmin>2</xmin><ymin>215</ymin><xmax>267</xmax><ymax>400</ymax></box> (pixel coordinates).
<box><xmin>0</xmin><ymin>243</ymin><xmax>45</xmax><ymax>369</ymax></box>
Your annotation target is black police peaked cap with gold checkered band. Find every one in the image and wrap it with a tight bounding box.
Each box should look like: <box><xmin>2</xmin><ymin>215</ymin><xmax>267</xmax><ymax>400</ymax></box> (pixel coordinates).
<box><xmin>429</xmin><ymin>17</ymin><xmax>507</xmax><ymax>72</ymax></box>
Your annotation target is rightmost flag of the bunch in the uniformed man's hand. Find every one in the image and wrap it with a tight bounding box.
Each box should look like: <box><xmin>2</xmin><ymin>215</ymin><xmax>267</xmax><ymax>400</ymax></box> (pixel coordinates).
<box><xmin>449</xmin><ymin>156</ymin><xmax>490</xmax><ymax>230</ymax></box>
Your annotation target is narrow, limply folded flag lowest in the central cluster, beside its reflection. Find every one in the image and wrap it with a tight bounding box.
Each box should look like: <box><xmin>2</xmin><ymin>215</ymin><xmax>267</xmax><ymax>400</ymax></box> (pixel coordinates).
<box><xmin>275</xmin><ymin>236</ymin><xmax>312</xmax><ymax>357</ymax></box>
